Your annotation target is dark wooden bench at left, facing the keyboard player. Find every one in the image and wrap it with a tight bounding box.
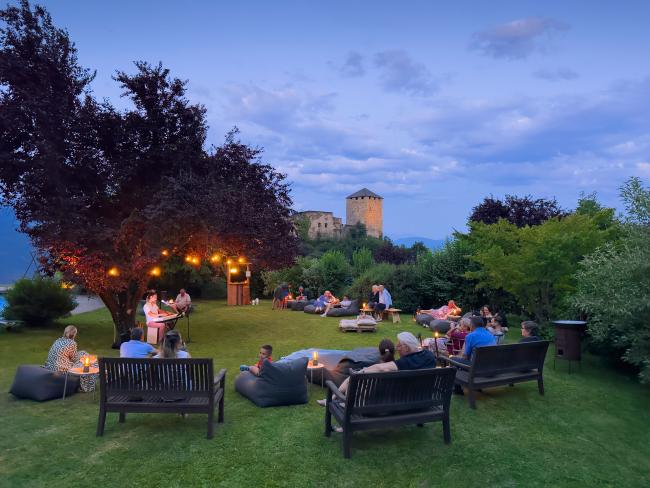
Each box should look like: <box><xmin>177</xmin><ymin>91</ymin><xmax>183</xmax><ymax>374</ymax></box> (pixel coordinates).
<box><xmin>97</xmin><ymin>358</ymin><xmax>226</xmax><ymax>439</ymax></box>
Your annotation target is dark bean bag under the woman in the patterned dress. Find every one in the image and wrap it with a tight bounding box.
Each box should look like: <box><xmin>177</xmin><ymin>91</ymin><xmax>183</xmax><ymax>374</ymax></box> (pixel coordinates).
<box><xmin>9</xmin><ymin>364</ymin><xmax>79</xmax><ymax>402</ymax></box>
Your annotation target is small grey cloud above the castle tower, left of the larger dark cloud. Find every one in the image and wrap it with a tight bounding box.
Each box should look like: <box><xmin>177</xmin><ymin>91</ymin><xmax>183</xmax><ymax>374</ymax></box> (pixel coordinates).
<box><xmin>374</xmin><ymin>50</ymin><xmax>439</xmax><ymax>96</ymax></box>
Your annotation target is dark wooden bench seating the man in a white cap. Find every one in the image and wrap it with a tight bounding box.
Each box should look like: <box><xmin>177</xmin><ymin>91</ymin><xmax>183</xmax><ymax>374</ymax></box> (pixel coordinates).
<box><xmin>325</xmin><ymin>368</ymin><xmax>456</xmax><ymax>458</ymax></box>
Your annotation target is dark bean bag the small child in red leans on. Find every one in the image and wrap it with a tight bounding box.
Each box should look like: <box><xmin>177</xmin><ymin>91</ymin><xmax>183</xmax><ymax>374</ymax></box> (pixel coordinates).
<box><xmin>235</xmin><ymin>358</ymin><xmax>308</xmax><ymax>407</ymax></box>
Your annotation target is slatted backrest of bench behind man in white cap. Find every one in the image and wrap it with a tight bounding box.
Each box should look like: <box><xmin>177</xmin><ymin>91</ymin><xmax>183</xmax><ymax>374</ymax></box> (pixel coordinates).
<box><xmin>346</xmin><ymin>368</ymin><xmax>456</xmax><ymax>415</ymax></box>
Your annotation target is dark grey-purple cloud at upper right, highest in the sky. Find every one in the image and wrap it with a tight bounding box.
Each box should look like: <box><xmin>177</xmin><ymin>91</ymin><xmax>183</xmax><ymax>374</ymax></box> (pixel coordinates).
<box><xmin>470</xmin><ymin>17</ymin><xmax>569</xmax><ymax>60</ymax></box>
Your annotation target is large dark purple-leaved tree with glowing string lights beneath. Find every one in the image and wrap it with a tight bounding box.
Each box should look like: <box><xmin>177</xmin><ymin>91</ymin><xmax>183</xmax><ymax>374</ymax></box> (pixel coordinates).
<box><xmin>0</xmin><ymin>0</ymin><xmax>296</xmax><ymax>344</ymax></box>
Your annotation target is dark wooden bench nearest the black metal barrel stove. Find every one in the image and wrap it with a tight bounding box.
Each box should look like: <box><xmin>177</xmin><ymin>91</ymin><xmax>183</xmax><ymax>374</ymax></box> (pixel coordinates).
<box><xmin>448</xmin><ymin>341</ymin><xmax>549</xmax><ymax>408</ymax></box>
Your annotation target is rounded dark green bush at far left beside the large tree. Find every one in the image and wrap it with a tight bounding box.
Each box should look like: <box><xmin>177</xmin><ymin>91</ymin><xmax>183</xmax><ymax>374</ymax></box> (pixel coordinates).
<box><xmin>4</xmin><ymin>277</ymin><xmax>77</xmax><ymax>326</ymax></box>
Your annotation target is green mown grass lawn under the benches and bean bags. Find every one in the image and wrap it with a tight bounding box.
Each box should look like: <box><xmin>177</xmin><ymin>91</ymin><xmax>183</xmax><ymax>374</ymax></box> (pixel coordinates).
<box><xmin>0</xmin><ymin>302</ymin><xmax>650</xmax><ymax>488</ymax></box>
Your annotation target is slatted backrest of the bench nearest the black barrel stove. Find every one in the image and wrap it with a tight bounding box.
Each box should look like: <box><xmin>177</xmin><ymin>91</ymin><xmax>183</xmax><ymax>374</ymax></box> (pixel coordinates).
<box><xmin>470</xmin><ymin>341</ymin><xmax>549</xmax><ymax>376</ymax></box>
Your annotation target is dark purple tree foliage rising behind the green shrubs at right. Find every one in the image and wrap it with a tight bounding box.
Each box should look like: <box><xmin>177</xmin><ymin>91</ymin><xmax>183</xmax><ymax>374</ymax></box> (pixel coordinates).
<box><xmin>469</xmin><ymin>195</ymin><xmax>566</xmax><ymax>227</ymax></box>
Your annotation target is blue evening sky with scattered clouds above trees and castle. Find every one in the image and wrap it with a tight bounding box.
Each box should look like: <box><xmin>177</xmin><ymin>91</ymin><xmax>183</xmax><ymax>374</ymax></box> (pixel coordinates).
<box><xmin>0</xmin><ymin>0</ymin><xmax>650</xmax><ymax>281</ymax></box>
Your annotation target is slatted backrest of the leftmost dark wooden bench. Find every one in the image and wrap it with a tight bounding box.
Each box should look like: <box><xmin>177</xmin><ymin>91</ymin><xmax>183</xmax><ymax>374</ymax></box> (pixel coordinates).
<box><xmin>99</xmin><ymin>358</ymin><xmax>214</xmax><ymax>400</ymax></box>
